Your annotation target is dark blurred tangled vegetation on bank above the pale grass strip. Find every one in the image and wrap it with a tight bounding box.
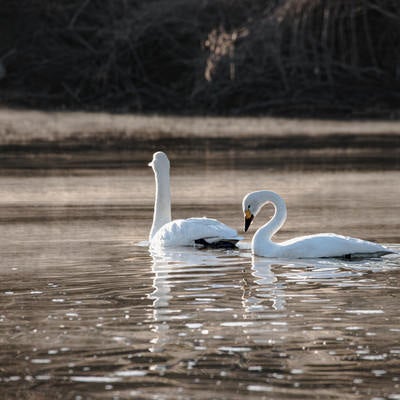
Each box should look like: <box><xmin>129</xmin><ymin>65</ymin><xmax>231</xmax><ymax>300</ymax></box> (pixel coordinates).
<box><xmin>0</xmin><ymin>0</ymin><xmax>400</xmax><ymax>117</ymax></box>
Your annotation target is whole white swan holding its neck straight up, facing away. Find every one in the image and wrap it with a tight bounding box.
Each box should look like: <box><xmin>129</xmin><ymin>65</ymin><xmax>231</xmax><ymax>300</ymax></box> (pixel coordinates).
<box><xmin>149</xmin><ymin>151</ymin><xmax>243</xmax><ymax>247</ymax></box>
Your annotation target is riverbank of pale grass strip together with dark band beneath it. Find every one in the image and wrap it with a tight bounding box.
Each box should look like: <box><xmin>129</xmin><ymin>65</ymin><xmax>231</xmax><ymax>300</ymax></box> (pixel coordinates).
<box><xmin>0</xmin><ymin>109</ymin><xmax>400</xmax><ymax>169</ymax></box>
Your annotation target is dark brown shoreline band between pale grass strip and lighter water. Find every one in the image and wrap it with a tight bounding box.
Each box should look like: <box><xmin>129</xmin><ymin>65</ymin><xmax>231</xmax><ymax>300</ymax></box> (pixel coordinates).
<box><xmin>0</xmin><ymin>134</ymin><xmax>400</xmax><ymax>170</ymax></box>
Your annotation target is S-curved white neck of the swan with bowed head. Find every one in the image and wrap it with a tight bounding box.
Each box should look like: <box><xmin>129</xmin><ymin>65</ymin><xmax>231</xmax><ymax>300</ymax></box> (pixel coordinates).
<box><xmin>252</xmin><ymin>190</ymin><xmax>287</xmax><ymax>249</ymax></box>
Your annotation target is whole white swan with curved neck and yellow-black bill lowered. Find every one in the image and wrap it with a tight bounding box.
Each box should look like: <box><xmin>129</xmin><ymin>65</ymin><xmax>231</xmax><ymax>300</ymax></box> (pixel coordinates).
<box><xmin>242</xmin><ymin>190</ymin><xmax>392</xmax><ymax>258</ymax></box>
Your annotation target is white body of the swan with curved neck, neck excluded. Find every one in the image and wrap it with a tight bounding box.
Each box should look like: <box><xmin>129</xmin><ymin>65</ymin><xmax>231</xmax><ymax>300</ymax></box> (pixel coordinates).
<box><xmin>279</xmin><ymin>233</ymin><xmax>391</xmax><ymax>258</ymax></box>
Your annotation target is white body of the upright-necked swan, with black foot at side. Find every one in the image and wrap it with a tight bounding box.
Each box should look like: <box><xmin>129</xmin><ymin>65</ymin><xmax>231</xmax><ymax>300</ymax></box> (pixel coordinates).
<box><xmin>150</xmin><ymin>217</ymin><xmax>242</xmax><ymax>247</ymax></box>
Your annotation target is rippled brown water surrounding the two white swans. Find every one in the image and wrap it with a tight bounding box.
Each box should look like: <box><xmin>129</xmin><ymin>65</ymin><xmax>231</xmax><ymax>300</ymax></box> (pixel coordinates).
<box><xmin>0</xmin><ymin>160</ymin><xmax>400</xmax><ymax>400</ymax></box>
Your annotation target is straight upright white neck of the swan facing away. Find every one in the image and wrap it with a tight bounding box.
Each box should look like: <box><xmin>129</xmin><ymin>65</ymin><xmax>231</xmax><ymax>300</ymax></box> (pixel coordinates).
<box><xmin>149</xmin><ymin>165</ymin><xmax>171</xmax><ymax>240</ymax></box>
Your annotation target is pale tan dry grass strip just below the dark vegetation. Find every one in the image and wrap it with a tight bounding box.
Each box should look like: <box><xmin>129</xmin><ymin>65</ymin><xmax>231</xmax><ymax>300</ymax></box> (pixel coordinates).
<box><xmin>0</xmin><ymin>109</ymin><xmax>400</xmax><ymax>146</ymax></box>
